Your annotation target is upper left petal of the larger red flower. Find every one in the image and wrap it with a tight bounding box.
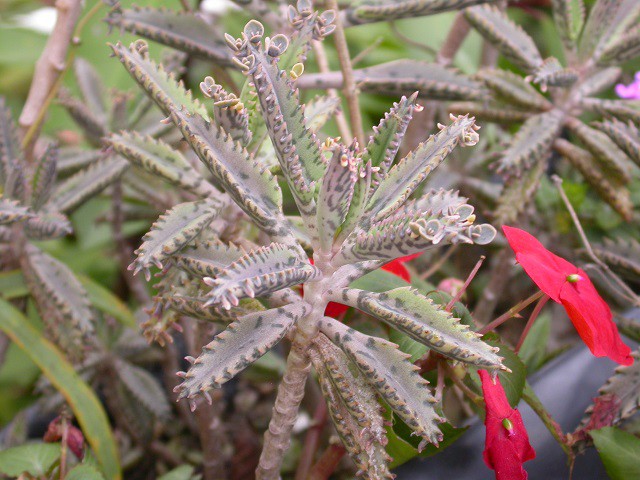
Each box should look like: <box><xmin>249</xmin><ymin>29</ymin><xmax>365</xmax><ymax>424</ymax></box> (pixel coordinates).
<box><xmin>502</xmin><ymin>225</ymin><xmax>578</xmax><ymax>303</ymax></box>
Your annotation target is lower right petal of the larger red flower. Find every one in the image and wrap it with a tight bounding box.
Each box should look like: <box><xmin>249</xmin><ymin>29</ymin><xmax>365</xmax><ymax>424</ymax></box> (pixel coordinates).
<box><xmin>560</xmin><ymin>270</ymin><xmax>633</xmax><ymax>365</ymax></box>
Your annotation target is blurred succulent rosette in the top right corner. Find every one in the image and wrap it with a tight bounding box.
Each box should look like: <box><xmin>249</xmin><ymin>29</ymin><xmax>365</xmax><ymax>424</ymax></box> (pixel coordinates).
<box><xmin>451</xmin><ymin>0</ymin><xmax>640</xmax><ymax>223</ymax></box>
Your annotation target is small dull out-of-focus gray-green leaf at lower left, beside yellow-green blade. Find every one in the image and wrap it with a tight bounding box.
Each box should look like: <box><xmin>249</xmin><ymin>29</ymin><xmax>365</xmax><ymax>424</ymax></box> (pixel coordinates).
<box><xmin>115</xmin><ymin>358</ymin><xmax>171</xmax><ymax>419</ymax></box>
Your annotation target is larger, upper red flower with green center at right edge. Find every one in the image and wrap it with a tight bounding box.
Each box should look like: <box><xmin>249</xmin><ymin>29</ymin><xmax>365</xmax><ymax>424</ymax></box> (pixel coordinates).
<box><xmin>502</xmin><ymin>226</ymin><xmax>633</xmax><ymax>365</ymax></box>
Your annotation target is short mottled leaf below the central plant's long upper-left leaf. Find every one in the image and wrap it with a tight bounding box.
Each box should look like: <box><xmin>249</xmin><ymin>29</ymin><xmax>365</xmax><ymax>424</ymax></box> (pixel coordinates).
<box><xmin>107</xmin><ymin>132</ymin><xmax>218</xmax><ymax>198</ymax></box>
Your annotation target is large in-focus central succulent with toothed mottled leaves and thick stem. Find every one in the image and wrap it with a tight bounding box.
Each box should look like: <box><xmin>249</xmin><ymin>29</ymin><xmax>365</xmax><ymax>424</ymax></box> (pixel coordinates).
<box><xmin>107</xmin><ymin>2</ymin><xmax>506</xmax><ymax>472</ymax></box>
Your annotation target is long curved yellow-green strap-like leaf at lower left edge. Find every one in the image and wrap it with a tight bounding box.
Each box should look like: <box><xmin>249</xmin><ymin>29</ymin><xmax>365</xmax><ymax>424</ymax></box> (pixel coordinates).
<box><xmin>0</xmin><ymin>300</ymin><xmax>122</xmax><ymax>480</ymax></box>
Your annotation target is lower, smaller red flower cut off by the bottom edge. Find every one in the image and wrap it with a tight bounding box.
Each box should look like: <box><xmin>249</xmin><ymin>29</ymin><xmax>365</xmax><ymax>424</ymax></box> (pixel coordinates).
<box><xmin>478</xmin><ymin>370</ymin><xmax>536</xmax><ymax>480</ymax></box>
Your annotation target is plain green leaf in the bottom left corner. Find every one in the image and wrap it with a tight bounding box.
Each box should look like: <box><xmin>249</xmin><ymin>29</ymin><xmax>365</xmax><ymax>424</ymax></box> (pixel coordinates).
<box><xmin>0</xmin><ymin>443</ymin><xmax>60</xmax><ymax>477</ymax></box>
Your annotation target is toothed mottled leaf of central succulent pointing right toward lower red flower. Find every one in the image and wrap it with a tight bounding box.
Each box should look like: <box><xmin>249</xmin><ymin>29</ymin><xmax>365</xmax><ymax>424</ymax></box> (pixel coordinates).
<box><xmin>336</xmin><ymin>287</ymin><xmax>504</xmax><ymax>370</ymax></box>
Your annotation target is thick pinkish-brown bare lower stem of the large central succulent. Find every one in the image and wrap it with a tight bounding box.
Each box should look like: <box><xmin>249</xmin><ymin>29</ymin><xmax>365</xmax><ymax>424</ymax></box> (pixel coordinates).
<box><xmin>256</xmin><ymin>341</ymin><xmax>311</xmax><ymax>480</ymax></box>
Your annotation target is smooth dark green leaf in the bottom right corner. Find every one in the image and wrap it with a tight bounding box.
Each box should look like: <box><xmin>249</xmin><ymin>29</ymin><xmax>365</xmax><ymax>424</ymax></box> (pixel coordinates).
<box><xmin>589</xmin><ymin>427</ymin><xmax>640</xmax><ymax>480</ymax></box>
